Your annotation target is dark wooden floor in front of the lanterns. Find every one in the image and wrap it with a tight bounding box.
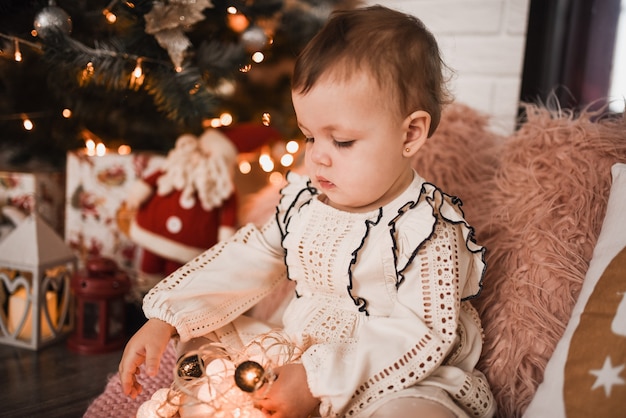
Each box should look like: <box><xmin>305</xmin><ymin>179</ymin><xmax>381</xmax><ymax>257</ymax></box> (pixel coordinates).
<box><xmin>0</xmin><ymin>341</ymin><xmax>122</xmax><ymax>418</ymax></box>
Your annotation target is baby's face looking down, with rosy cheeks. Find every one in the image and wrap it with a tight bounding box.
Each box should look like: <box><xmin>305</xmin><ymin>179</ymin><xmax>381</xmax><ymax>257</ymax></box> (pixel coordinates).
<box><xmin>292</xmin><ymin>73</ymin><xmax>413</xmax><ymax>212</ymax></box>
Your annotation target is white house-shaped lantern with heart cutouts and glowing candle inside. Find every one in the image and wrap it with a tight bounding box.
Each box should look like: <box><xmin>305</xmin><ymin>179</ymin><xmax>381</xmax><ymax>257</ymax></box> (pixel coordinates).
<box><xmin>0</xmin><ymin>213</ymin><xmax>77</xmax><ymax>350</ymax></box>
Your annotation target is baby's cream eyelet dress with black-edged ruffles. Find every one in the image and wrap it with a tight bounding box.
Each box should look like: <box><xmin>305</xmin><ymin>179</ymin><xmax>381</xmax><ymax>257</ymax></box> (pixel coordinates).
<box><xmin>144</xmin><ymin>173</ymin><xmax>495</xmax><ymax>417</ymax></box>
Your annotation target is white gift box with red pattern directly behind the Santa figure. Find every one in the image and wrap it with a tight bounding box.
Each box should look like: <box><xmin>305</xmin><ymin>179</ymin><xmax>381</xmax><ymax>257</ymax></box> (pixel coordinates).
<box><xmin>65</xmin><ymin>150</ymin><xmax>163</xmax><ymax>275</ymax></box>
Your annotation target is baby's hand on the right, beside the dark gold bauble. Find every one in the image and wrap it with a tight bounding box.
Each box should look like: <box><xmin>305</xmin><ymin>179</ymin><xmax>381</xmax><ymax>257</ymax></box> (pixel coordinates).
<box><xmin>257</xmin><ymin>364</ymin><xmax>319</xmax><ymax>418</ymax></box>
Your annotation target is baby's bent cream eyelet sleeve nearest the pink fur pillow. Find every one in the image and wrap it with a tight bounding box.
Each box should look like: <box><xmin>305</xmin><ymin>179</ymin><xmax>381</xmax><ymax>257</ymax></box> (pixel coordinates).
<box><xmin>303</xmin><ymin>187</ymin><xmax>484</xmax><ymax>416</ymax></box>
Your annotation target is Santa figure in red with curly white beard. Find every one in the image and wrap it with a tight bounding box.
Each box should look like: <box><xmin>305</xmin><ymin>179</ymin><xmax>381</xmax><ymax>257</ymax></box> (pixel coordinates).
<box><xmin>126</xmin><ymin>129</ymin><xmax>237</xmax><ymax>278</ymax></box>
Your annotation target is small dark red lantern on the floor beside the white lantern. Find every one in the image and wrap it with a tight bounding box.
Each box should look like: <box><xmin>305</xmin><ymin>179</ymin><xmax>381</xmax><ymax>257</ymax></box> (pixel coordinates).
<box><xmin>68</xmin><ymin>257</ymin><xmax>130</xmax><ymax>354</ymax></box>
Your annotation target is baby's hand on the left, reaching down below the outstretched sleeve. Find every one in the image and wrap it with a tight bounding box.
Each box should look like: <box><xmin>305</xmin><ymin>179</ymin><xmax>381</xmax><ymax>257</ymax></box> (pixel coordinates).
<box><xmin>119</xmin><ymin>319</ymin><xmax>176</xmax><ymax>399</ymax></box>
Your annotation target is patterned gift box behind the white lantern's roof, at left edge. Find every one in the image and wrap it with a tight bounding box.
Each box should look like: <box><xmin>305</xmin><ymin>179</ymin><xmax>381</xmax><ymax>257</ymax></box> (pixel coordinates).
<box><xmin>0</xmin><ymin>169</ymin><xmax>65</xmax><ymax>241</ymax></box>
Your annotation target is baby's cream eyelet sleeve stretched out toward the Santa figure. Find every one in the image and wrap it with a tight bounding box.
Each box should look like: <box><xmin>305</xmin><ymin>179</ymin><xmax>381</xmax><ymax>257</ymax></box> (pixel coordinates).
<box><xmin>143</xmin><ymin>171</ymin><xmax>314</xmax><ymax>341</ymax></box>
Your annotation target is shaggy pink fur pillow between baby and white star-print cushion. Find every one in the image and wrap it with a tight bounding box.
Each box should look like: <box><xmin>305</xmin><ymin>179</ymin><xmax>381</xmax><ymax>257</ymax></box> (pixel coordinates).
<box><xmin>468</xmin><ymin>105</ymin><xmax>626</xmax><ymax>418</ymax></box>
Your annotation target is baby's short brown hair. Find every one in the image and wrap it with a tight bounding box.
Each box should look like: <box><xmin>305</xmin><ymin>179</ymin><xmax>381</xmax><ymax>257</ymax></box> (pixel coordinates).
<box><xmin>292</xmin><ymin>5</ymin><xmax>451</xmax><ymax>136</ymax></box>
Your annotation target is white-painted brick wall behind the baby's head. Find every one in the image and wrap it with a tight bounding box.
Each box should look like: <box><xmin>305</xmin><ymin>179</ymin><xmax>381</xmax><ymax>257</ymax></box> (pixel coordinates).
<box><xmin>365</xmin><ymin>0</ymin><xmax>529</xmax><ymax>134</ymax></box>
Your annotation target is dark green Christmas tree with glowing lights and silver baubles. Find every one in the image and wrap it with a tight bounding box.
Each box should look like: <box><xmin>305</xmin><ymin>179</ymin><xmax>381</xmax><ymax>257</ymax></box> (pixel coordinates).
<box><xmin>0</xmin><ymin>0</ymin><xmax>356</xmax><ymax>166</ymax></box>
